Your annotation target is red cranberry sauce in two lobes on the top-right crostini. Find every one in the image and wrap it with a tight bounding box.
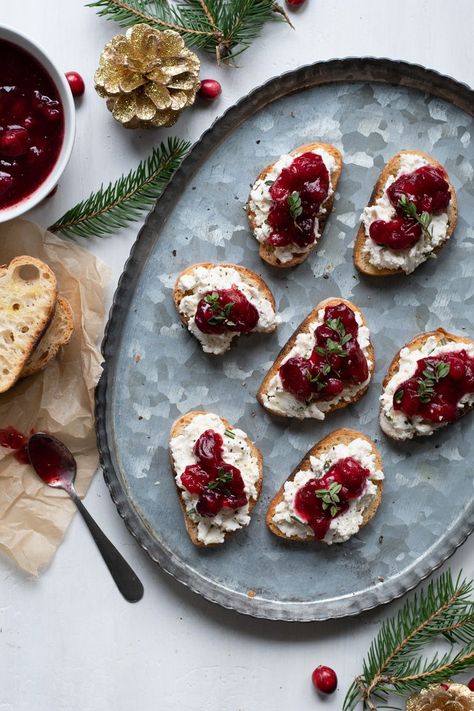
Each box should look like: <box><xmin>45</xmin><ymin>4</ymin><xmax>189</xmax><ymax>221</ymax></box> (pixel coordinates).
<box><xmin>369</xmin><ymin>165</ymin><xmax>451</xmax><ymax>250</ymax></box>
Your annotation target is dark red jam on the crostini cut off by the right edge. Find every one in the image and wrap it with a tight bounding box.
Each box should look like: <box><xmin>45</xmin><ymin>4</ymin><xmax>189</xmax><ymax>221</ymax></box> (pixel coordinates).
<box><xmin>393</xmin><ymin>350</ymin><xmax>474</xmax><ymax>423</ymax></box>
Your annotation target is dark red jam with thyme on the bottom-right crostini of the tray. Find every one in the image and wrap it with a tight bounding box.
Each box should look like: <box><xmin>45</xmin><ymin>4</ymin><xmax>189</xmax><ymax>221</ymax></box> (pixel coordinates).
<box><xmin>294</xmin><ymin>457</ymin><xmax>370</xmax><ymax>541</ymax></box>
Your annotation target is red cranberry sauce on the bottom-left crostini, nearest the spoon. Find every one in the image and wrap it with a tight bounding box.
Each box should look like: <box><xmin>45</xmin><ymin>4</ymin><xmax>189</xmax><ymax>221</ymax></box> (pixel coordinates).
<box><xmin>181</xmin><ymin>430</ymin><xmax>248</xmax><ymax>516</ymax></box>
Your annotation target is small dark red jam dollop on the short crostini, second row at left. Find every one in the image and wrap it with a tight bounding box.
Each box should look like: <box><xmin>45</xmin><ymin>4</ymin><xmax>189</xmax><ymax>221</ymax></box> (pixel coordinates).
<box><xmin>194</xmin><ymin>286</ymin><xmax>259</xmax><ymax>333</ymax></box>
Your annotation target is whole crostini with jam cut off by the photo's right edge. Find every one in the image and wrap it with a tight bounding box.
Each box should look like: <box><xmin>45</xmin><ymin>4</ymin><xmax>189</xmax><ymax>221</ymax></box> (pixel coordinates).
<box><xmin>380</xmin><ymin>328</ymin><xmax>474</xmax><ymax>440</ymax></box>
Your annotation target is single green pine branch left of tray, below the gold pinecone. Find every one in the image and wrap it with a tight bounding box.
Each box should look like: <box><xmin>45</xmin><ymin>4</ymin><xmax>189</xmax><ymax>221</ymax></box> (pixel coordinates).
<box><xmin>48</xmin><ymin>138</ymin><xmax>191</xmax><ymax>237</ymax></box>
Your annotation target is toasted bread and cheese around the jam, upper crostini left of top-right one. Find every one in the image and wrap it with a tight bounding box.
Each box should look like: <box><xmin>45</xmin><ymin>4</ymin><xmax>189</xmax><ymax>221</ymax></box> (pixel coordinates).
<box><xmin>246</xmin><ymin>143</ymin><xmax>342</xmax><ymax>269</ymax></box>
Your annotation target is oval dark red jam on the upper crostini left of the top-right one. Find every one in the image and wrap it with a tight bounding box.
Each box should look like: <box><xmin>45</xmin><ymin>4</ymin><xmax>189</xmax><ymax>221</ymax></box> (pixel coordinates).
<box><xmin>266</xmin><ymin>153</ymin><xmax>330</xmax><ymax>247</ymax></box>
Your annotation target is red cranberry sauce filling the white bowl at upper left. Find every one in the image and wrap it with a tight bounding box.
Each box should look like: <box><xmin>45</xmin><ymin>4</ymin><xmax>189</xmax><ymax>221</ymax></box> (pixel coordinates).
<box><xmin>0</xmin><ymin>40</ymin><xmax>64</xmax><ymax>209</ymax></box>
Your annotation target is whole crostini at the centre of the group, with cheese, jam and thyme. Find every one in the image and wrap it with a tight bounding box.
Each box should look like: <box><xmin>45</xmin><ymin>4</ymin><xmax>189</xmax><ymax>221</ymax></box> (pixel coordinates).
<box><xmin>257</xmin><ymin>297</ymin><xmax>375</xmax><ymax>420</ymax></box>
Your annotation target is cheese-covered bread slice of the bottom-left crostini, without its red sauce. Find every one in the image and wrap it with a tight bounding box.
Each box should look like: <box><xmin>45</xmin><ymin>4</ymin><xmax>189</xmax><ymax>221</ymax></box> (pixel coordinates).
<box><xmin>169</xmin><ymin>411</ymin><xmax>263</xmax><ymax>548</ymax></box>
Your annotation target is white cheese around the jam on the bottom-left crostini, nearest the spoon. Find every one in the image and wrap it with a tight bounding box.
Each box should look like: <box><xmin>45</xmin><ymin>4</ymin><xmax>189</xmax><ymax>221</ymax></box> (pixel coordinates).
<box><xmin>170</xmin><ymin>412</ymin><xmax>260</xmax><ymax>545</ymax></box>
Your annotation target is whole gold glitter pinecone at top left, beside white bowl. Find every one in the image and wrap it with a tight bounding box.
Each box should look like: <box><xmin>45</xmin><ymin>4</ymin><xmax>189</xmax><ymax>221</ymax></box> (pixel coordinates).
<box><xmin>94</xmin><ymin>24</ymin><xmax>200</xmax><ymax>128</ymax></box>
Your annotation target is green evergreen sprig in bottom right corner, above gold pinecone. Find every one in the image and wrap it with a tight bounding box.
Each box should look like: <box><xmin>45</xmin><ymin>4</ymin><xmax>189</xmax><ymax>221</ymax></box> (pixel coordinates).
<box><xmin>343</xmin><ymin>571</ymin><xmax>474</xmax><ymax>711</ymax></box>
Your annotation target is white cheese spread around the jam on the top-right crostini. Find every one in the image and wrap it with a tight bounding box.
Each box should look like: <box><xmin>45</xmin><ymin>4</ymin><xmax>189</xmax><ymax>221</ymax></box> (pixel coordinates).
<box><xmin>361</xmin><ymin>153</ymin><xmax>449</xmax><ymax>274</ymax></box>
